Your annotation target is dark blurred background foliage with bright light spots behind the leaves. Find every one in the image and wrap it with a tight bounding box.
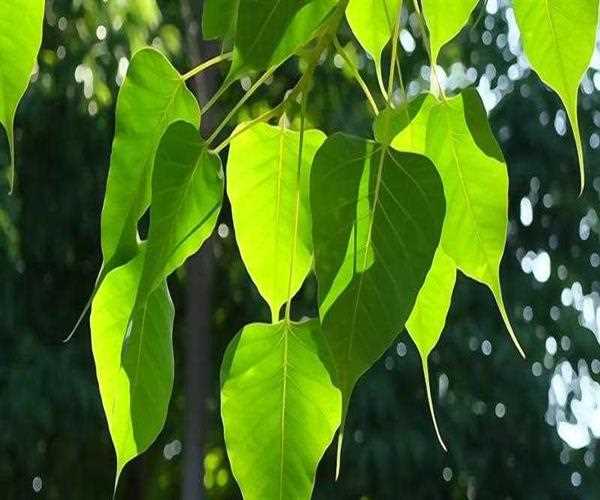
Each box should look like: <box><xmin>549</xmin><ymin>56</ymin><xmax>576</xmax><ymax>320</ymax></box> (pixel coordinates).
<box><xmin>0</xmin><ymin>0</ymin><xmax>600</xmax><ymax>500</ymax></box>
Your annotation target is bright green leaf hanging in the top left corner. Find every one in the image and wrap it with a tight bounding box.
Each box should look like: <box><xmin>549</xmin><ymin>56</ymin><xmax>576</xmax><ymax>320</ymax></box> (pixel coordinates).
<box><xmin>0</xmin><ymin>0</ymin><xmax>44</xmax><ymax>191</ymax></box>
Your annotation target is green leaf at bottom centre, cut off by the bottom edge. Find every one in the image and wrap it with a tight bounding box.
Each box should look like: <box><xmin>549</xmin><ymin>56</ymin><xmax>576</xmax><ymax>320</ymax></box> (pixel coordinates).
<box><xmin>221</xmin><ymin>320</ymin><xmax>341</xmax><ymax>500</ymax></box>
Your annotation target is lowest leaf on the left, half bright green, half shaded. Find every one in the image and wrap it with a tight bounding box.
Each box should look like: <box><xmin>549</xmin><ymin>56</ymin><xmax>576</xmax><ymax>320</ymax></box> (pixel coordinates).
<box><xmin>90</xmin><ymin>250</ymin><xmax>174</xmax><ymax>488</ymax></box>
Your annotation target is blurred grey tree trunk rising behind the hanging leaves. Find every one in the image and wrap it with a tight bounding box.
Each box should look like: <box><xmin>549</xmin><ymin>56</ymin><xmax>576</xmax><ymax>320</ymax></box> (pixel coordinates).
<box><xmin>181</xmin><ymin>0</ymin><xmax>217</xmax><ymax>500</ymax></box>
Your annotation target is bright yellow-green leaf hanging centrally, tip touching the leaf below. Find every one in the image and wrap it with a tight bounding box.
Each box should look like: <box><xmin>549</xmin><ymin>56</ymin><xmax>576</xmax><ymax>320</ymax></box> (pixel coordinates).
<box><xmin>227</xmin><ymin>123</ymin><xmax>325</xmax><ymax>321</ymax></box>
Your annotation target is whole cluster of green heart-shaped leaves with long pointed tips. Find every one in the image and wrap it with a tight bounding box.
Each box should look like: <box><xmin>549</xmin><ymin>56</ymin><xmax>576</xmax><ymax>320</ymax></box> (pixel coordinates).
<box><xmin>0</xmin><ymin>0</ymin><xmax>598</xmax><ymax>498</ymax></box>
